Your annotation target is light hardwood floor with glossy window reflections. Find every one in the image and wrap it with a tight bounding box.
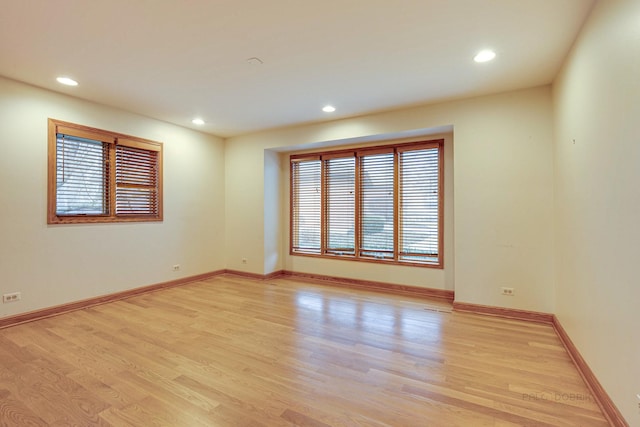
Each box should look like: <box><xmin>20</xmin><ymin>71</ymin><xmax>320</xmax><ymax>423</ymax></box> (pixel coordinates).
<box><xmin>0</xmin><ymin>275</ymin><xmax>607</xmax><ymax>427</ymax></box>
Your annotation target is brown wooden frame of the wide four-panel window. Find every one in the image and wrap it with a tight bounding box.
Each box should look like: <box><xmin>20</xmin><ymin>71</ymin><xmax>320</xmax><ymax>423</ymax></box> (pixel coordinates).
<box><xmin>289</xmin><ymin>139</ymin><xmax>444</xmax><ymax>269</ymax></box>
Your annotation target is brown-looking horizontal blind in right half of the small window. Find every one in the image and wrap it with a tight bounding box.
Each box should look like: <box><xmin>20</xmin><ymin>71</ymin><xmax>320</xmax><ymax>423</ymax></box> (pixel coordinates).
<box><xmin>116</xmin><ymin>145</ymin><xmax>158</xmax><ymax>215</ymax></box>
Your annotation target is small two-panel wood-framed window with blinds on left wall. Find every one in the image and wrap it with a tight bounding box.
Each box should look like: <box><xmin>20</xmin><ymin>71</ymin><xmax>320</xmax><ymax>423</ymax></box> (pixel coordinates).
<box><xmin>48</xmin><ymin>119</ymin><xmax>162</xmax><ymax>224</ymax></box>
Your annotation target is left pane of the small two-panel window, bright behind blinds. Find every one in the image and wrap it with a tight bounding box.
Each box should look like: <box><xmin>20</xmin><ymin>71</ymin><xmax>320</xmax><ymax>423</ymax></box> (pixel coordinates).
<box><xmin>56</xmin><ymin>134</ymin><xmax>109</xmax><ymax>215</ymax></box>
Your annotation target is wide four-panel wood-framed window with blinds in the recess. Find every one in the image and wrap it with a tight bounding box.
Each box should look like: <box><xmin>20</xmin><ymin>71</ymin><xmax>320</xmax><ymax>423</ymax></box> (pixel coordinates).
<box><xmin>291</xmin><ymin>140</ymin><xmax>443</xmax><ymax>267</ymax></box>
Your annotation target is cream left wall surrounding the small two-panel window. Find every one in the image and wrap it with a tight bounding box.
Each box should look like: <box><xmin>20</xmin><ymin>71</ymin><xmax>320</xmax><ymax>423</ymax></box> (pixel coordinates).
<box><xmin>0</xmin><ymin>78</ymin><xmax>225</xmax><ymax>317</ymax></box>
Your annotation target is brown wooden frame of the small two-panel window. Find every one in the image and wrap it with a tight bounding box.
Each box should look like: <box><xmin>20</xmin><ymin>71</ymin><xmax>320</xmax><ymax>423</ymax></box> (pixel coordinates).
<box><xmin>47</xmin><ymin>118</ymin><xmax>163</xmax><ymax>224</ymax></box>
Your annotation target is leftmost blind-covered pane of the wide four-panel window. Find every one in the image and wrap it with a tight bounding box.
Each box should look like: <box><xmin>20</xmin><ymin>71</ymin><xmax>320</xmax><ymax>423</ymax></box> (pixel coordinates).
<box><xmin>291</xmin><ymin>160</ymin><xmax>321</xmax><ymax>253</ymax></box>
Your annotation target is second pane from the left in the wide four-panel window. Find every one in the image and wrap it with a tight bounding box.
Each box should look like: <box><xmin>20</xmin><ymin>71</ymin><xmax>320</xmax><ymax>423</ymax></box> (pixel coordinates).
<box><xmin>325</xmin><ymin>157</ymin><xmax>356</xmax><ymax>254</ymax></box>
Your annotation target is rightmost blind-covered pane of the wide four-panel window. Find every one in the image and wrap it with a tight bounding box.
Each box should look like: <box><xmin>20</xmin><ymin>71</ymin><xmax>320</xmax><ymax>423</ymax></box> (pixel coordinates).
<box><xmin>399</xmin><ymin>148</ymin><xmax>440</xmax><ymax>261</ymax></box>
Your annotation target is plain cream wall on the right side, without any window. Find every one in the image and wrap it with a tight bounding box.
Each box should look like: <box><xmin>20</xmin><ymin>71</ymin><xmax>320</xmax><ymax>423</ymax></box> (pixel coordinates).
<box><xmin>554</xmin><ymin>0</ymin><xmax>640</xmax><ymax>426</ymax></box>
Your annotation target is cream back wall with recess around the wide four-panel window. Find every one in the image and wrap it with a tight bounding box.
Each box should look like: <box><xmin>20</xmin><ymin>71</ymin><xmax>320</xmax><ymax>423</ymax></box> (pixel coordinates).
<box><xmin>225</xmin><ymin>87</ymin><xmax>554</xmax><ymax>312</ymax></box>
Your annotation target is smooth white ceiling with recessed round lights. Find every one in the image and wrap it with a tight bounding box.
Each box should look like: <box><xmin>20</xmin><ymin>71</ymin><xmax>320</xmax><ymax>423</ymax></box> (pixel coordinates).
<box><xmin>0</xmin><ymin>0</ymin><xmax>594</xmax><ymax>136</ymax></box>
